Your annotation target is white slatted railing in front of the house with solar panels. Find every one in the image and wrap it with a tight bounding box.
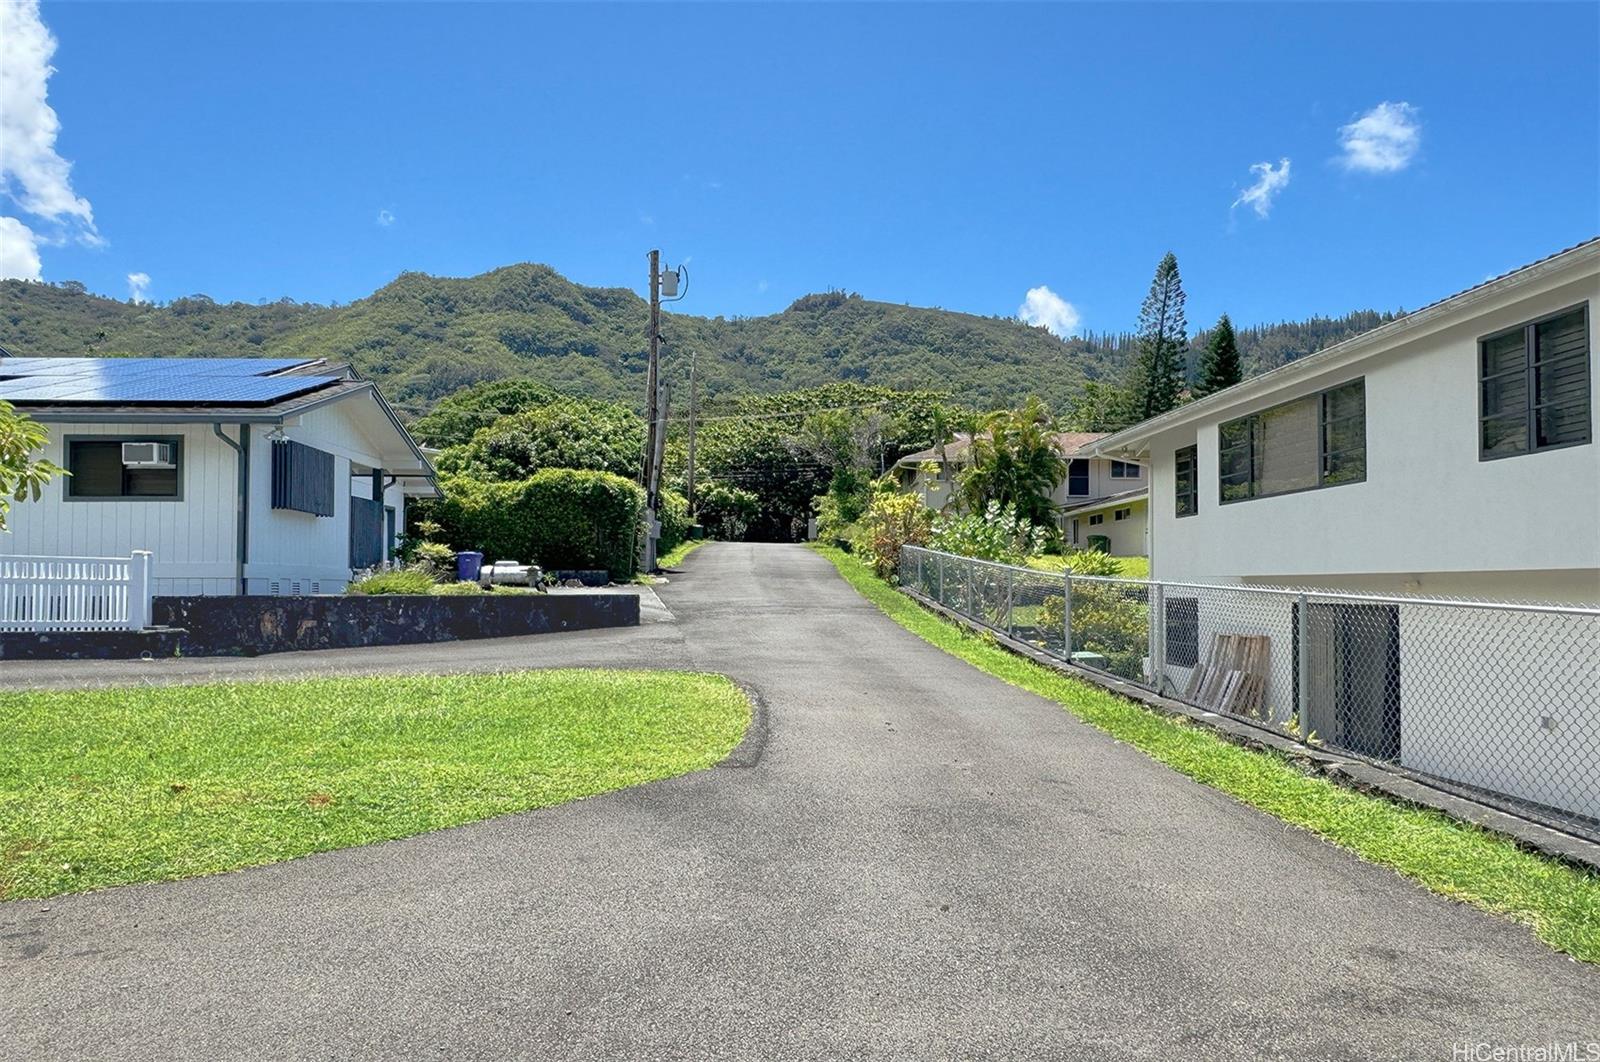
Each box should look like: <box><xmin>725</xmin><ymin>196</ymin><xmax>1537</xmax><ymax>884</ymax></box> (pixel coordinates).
<box><xmin>0</xmin><ymin>550</ymin><xmax>150</xmax><ymax>630</ymax></box>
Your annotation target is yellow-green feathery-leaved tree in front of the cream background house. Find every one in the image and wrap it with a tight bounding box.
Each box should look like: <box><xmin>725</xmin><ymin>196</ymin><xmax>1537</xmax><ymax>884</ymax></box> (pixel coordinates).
<box><xmin>960</xmin><ymin>398</ymin><xmax>1067</xmax><ymax>526</ymax></box>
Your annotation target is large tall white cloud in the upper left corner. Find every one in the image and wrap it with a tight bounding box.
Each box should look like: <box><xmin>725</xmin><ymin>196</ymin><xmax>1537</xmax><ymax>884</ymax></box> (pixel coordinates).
<box><xmin>0</xmin><ymin>0</ymin><xmax>104</xmax><ymax>263</ymax></box>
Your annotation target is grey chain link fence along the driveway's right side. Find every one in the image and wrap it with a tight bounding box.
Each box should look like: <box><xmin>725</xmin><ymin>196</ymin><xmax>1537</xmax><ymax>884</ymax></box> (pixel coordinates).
<box><xmin>899</xmin><ymin>547</ymin><xmax>1600</xmax><ymax>841</ymax></box>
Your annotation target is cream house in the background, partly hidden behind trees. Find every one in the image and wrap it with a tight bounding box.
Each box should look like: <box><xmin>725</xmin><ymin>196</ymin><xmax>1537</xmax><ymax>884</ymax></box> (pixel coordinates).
<box><xmin>894</xmin><ymin>432</ymin><xmax>1149</xmax><ymax>557</ymax></box>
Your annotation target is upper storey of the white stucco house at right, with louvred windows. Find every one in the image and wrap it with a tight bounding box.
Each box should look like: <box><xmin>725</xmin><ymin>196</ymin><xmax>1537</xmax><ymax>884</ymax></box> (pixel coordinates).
<box><xmin>1091</xmin><ymin>240</ymin><xmax>1600</xmax><ymax>601</ymax></box>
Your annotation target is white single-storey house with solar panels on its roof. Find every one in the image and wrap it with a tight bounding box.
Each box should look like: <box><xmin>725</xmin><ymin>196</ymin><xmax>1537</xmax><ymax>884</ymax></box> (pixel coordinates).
<box><xmin>0</xmin><ymin>357</ymin><xmax>437</xmax><ymax>595</ymax></box>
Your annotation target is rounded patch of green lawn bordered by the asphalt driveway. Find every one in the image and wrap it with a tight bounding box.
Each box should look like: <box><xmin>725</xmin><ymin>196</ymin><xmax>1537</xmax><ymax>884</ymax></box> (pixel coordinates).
<box><xmin>0</xmin><ymin>670</ymin><xmax>750</xmax><ymax>899</ymax></box>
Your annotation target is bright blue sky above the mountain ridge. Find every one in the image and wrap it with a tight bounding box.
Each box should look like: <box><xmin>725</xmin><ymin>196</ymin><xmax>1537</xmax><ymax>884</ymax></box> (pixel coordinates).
<box><xmin>0</xmin><ymin>3</ymin><xmax>1600</xmax><ymax>331</ymax></box>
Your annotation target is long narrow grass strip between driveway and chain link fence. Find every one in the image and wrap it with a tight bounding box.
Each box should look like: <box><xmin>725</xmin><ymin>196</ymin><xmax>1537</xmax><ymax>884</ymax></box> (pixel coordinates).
<box><xmin>818</xmin><ymin>547</ymin><xmax>1600</xmax><ymax>963</ymax></box>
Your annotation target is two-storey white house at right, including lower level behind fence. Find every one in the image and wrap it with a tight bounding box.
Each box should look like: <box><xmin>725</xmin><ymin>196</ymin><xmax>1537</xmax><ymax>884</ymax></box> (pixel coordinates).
<box><xmin>1094</xmin><ymin>240</ymin><xmax>1600</xmax><ymax>817</ymax></box>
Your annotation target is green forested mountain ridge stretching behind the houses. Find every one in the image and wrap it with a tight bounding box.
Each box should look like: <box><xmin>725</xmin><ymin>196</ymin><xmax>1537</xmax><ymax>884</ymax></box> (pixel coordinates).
<box><xmin>0</xmin><ymin>264</ymin><xmax>1386</xmax><ymax>416</ymax></box>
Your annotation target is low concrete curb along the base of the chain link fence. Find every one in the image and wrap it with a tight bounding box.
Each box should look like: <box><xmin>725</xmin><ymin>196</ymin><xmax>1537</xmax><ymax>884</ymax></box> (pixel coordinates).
<box><xmin>899</xmin><ymin>587</ymin><xmax>1600</xmax><ymax>873</ymax></box>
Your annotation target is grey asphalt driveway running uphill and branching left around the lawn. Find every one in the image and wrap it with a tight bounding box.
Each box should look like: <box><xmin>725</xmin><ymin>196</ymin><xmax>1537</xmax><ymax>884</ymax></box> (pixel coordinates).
<box><xmin>0</xmin><ymin>544</ymin><xmax>1600</xmax><ymax>1059</ymax></box>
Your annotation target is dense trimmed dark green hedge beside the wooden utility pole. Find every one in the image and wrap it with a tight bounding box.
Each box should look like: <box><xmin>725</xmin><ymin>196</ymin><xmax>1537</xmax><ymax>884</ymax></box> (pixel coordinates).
<box><xmin>432</xmin><ymin>469</ymin><xmax>645</xmax><ymax>582</ymax></box>
